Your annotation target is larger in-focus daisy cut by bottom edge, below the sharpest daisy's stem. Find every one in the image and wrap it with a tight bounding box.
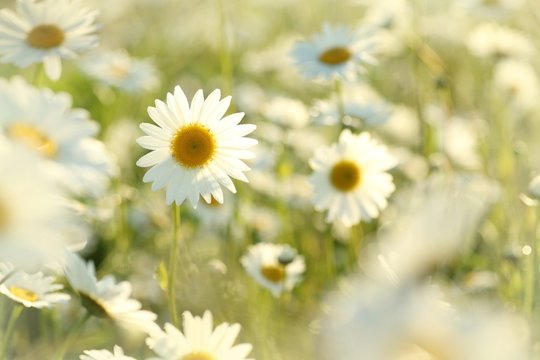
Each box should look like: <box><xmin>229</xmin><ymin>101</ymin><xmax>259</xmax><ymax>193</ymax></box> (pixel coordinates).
<box><xmin>146</xmin><ymin>311</ymin><xmax>252</xmax><ymax>360</ymax></box>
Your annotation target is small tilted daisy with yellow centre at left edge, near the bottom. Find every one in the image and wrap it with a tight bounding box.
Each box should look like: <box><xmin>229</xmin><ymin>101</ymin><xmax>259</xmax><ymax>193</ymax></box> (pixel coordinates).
<box><xmin>0</xmin><ymin>263</ymin><xmax>70</xmax><ymax>309</ymax></box>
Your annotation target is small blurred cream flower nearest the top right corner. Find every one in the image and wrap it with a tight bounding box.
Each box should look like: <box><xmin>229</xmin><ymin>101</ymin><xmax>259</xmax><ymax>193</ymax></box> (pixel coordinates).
<box><xmin>466</xmin><ymin>23</ymin><xmax>534</xmax><ymax>59</ymax></box>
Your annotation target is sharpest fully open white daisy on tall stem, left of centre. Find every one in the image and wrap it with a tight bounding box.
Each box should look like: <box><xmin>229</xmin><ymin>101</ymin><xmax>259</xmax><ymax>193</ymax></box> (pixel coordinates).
<box><xmin>137</xmin><ymin>86</ymin><xmax>257</xmax><ymax>208</ymax></box>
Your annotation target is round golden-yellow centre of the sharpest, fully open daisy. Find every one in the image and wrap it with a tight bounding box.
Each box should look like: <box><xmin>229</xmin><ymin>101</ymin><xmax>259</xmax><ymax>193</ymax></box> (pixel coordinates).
<box><xmin>171</xmin><ymin>124</ymin><xmax>216</xmax><ymax>168</ymax></box>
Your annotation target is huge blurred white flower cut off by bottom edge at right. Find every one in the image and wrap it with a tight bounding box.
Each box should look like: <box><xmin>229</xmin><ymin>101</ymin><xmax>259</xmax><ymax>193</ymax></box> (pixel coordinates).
<box><xmin>319</xmin><ymin>278</ymin><xmax>531</xmax><ymax>360</ymax></box>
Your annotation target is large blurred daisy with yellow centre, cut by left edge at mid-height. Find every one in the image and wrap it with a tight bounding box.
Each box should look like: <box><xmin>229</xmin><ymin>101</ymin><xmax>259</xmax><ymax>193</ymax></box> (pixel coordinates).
<box><xmin>0</xmin><ymin>77</ymin><xmax>114</xmax><ymax>196</ymax></box>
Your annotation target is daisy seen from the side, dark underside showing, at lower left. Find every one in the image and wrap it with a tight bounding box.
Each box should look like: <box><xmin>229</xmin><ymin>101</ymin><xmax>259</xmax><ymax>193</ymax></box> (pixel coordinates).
<box><xmin>64</xmin><ymin>254</ymin><xmax>159</xmax><ymax>333</ymax></box>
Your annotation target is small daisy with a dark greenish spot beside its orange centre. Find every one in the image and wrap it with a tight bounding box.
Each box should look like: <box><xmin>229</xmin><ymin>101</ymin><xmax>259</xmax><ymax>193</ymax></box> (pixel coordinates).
<box><xmin>240</xmin><ymin>243</ymin><xmax>306</xmax><ymax>297</ymax></box>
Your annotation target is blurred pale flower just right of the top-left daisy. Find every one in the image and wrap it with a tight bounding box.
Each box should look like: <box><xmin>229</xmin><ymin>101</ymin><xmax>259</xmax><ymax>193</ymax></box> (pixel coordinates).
<box><xmin>81</xmin><ymin>49</ymin><xmax>159</xmax><ymax>93</ymax></box>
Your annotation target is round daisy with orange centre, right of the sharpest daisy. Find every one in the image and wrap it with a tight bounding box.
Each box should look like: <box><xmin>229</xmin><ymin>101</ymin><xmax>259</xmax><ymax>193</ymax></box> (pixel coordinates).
<box><xmin>310</xmin><ymin>130</ymin><xmax>396</xmax><ymax>226</ymax></box>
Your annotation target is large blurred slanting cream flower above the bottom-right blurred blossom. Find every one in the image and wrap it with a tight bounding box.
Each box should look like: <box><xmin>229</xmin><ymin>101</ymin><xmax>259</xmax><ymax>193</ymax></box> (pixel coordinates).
<box><xmin>364</xmin><ymin>175</ymin><xmax>499</xmax><ymax>281</ymax></box>
